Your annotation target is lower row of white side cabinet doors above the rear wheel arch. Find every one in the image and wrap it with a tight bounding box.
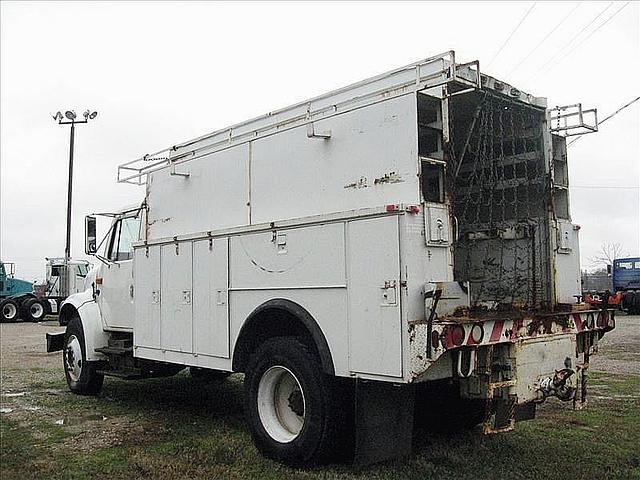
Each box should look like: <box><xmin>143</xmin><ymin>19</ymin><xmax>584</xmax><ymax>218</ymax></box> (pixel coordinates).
<box><xmin>134</xmin><ymin>210</ymin><xmax>410</xmax><ymax>379</ymax></box>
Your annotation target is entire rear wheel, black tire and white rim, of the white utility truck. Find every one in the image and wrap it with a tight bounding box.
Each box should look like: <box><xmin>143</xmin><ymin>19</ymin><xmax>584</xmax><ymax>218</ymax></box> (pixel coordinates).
<box><xmin>245</xmin><ymin>337</ymin><xmax>345</xmax><ymax>466</ymax></box>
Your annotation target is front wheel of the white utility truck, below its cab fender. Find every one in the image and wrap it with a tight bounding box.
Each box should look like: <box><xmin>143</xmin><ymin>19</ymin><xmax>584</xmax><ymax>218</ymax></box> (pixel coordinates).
<box><xmin>62</xmin><ymin>316</ymin><xmax>104</xmax><ymax>395</ymax></box>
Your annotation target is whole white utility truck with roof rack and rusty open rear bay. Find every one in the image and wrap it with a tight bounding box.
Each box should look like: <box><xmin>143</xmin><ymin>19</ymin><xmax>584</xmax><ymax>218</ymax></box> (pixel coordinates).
<box><xmin>48</xmin><ymin>52</ymin><xmax>614</xmax><ymax>465</ymax></box>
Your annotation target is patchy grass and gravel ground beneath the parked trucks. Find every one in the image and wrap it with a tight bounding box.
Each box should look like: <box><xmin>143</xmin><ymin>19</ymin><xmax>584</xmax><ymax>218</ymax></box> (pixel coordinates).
<box><xmin>0</xmin><ymin>316</ymin><xmax>640</xmax><ymax>480</ymax></box>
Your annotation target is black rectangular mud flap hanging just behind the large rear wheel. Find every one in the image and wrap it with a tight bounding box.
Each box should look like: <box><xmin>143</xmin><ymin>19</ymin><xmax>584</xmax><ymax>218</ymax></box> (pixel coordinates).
<box><xmin>354</xmin><ymin>380</ymin><xmax>415</xmax><ymax>466</ymax></box>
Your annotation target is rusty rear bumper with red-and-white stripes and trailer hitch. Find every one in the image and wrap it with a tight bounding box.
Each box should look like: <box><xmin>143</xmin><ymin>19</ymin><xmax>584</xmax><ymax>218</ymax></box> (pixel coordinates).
<box><xmin>408</xmin><ymin>309</ymin><xmax>615</xmax><ymax>433</ymax></box>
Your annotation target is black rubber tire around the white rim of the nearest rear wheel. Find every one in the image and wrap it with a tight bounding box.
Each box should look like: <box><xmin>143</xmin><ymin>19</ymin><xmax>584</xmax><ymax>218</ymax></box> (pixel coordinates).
<box><xmin>244</xmin><ymin>337</ymin><xmax>353</xmax><ymax>466</ymax></box>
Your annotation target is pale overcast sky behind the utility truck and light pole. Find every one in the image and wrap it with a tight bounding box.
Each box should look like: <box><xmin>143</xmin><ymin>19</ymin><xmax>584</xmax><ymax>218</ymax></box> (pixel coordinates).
<box><xmin>0</xmin><ymin>2</ymin><xmax>640</xmax><ymax>280</ymax></box>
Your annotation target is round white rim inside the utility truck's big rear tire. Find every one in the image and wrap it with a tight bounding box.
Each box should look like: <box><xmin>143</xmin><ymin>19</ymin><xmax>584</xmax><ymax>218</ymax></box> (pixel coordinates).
<box><xmin>258</xmin><ymin>366</ymin><xmax>306</xmax><ymax>443</ymax></box>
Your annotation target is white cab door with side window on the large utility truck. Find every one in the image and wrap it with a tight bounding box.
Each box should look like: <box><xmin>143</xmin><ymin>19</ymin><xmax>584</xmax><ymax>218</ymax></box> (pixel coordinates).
<box><xmin>97</xmin><ymin>214</ymin><xmax>140</xmax><ymax>329</ymax></box>
